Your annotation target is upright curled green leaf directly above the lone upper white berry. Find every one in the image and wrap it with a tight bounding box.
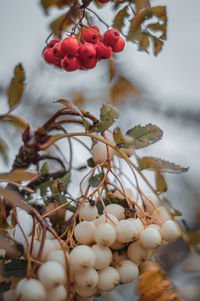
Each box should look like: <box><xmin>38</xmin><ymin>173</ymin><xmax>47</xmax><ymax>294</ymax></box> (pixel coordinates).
<box><xmin>96</xmin><ymin>104</ymin><xmax>119</xmax><ymax>133</ymax></box>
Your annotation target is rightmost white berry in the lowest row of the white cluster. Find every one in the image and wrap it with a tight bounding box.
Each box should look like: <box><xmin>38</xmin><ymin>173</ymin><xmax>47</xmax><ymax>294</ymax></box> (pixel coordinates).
<box><xmin>117</xmin><ymin>260</ymin><xmax>139</xmax><ymax>283</ymax></box>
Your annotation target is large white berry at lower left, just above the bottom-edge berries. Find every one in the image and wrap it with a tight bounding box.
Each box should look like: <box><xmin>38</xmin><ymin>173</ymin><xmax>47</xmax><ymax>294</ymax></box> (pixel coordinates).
<box><xmin>38</xmin><ymin>261</ymin><xmax>67</xmax><ymax>287</ymax></box>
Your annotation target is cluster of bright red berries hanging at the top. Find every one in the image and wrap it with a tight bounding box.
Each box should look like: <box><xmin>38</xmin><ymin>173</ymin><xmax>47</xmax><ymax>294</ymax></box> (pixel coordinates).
<box><xmin>43</xmin><ymin>26</ymin><xmax>125</xmax><ymax>71</ymax></box>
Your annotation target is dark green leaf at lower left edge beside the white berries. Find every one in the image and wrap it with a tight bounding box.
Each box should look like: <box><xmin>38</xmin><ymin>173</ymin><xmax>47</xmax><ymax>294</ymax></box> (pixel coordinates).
<box><xmin>2</xmin><ymin>260</ymin><xmax>27</xmax><ymax>278</ymax></box>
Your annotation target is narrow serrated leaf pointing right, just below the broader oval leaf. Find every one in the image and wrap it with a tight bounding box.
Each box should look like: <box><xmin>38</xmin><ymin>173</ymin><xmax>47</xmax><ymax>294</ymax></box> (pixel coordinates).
<box><xmin>138</xmin><ymin>157</ymin><xmax>188</xmax><ymax>174</ymax></box>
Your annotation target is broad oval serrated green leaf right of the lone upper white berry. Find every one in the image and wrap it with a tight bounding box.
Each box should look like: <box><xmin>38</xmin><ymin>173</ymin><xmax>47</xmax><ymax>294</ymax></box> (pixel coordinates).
<box><xmin>126</xmin><ymin>123</ymin><xmax>163</xmax><ymax>149</ymax></box>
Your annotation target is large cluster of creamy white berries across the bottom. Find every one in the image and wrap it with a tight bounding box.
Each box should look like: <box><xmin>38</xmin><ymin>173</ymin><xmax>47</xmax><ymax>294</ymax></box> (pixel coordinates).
<box><xmin>6</xmin><ymin>196</ymin><xmax>181</xmax><ymax>301</ymax></box>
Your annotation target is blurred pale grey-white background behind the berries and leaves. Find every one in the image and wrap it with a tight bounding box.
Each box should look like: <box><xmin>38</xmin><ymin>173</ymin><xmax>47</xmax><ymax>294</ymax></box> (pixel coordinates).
<box><xmin>0</xmin><ymin>0</ymin><xmax>200</xmax><ymax>301</ymax></box>
